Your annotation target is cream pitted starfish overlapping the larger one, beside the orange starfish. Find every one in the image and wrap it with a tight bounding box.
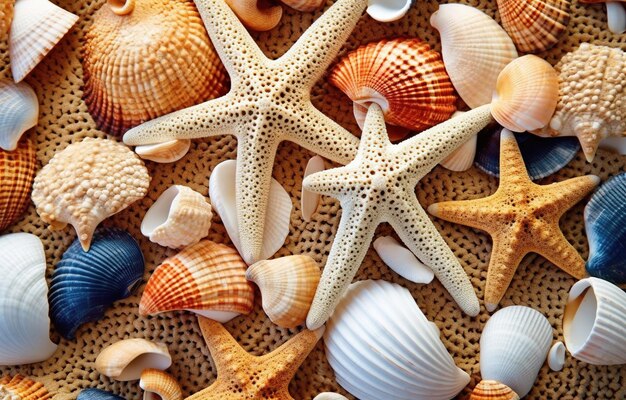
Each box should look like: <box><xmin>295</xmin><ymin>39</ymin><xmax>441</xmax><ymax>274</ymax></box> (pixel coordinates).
<box><xmin>303</xmin><ymin>104</ymin><xmax>491</xmax><ymax>329</ymax></box>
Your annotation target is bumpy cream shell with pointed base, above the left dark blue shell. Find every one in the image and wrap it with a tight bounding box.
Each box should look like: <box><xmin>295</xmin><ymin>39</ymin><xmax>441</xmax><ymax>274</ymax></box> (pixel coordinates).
<box><xmin>32</xmin><ymin>138</ymin><xmax>150</xmax><ymax>251</ymax></box>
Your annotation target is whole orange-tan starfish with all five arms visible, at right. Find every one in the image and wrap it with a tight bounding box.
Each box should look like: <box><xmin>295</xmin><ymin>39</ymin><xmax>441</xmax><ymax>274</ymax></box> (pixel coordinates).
<box><xmin>428</xmin><ymin>130</ymin><xmax>600</xmax><ymax>311</ymax></box>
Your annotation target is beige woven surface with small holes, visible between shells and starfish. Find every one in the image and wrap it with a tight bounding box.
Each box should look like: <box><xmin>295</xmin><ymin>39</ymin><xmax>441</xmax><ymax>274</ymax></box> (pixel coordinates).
<box><xmin>0</xmin><ymin>0</ymin><xmax>626</xmax><ymax>400</ymax></box>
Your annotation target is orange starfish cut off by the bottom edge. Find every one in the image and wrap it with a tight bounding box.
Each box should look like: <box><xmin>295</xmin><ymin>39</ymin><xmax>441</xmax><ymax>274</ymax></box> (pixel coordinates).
<box><xmin>186</xmin><ymin>317</ymin><xmax>324</xmax><ymax>400</ymax></box>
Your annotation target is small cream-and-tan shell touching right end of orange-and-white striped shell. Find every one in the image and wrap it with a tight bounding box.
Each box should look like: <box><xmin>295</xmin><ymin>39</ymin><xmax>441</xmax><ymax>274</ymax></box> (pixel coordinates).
<box><xmin>246</xmin><ymin>255</ymin><xmax>322</xmax><ymax>328</ymax></box>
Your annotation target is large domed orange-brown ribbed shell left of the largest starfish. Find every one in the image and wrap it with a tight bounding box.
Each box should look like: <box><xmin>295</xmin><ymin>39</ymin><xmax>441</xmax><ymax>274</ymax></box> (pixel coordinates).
<box><xmin>82</xmin><ymin>0</ymin><xmax>227</xmax><ymax>136</ymax></box>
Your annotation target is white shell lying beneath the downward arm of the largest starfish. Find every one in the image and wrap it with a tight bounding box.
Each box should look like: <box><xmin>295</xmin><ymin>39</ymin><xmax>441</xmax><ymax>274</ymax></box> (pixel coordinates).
<box><xmin>209</xmin><ymin>160</ymin><xmax>292</xmax><ymax>264</ymax></box>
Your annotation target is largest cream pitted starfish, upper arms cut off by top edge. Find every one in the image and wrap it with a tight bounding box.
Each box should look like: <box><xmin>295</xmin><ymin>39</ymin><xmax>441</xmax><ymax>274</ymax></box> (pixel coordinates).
<box><xmin>124</xmin><ymin>0</ymin><xmax>367</xmax><ymax>261</ymax></box>
